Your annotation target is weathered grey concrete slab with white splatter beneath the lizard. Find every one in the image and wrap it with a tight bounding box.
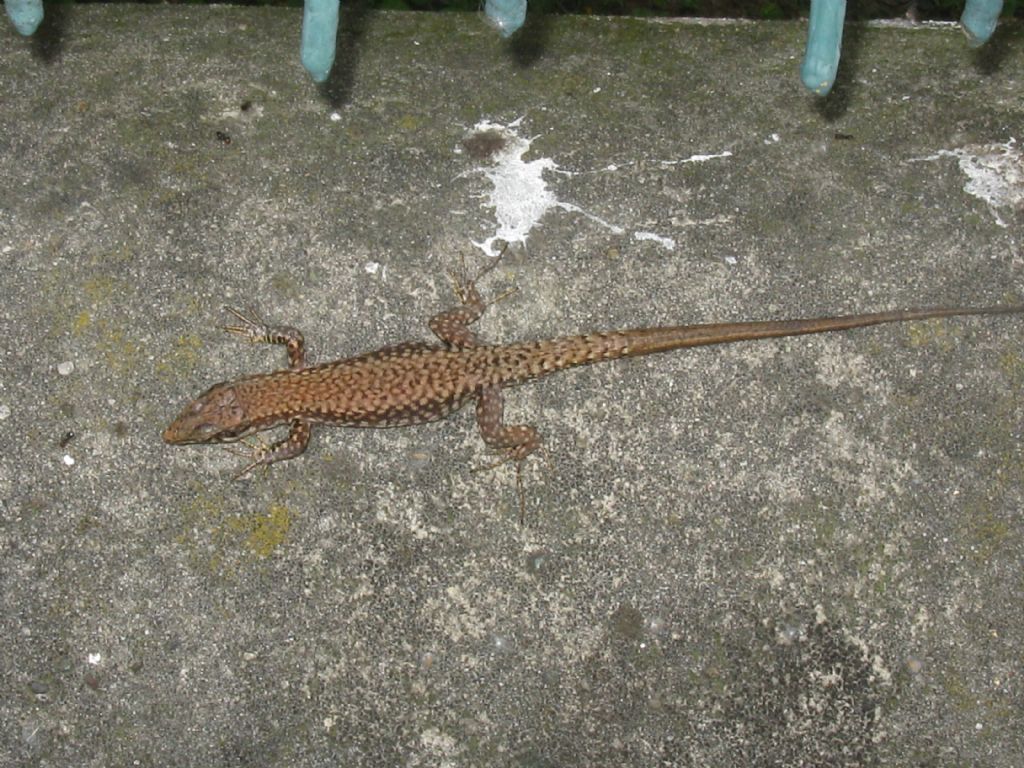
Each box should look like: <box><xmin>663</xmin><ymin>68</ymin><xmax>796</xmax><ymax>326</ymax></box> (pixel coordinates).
<box><xmin>0</xmin><ymin>6</ymin><xmax>1024</xmax><ymax>767</ymax></box>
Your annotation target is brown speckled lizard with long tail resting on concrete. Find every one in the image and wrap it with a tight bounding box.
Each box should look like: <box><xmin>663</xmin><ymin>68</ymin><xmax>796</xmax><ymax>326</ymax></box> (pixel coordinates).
<box><xmin>164</xmin><ymin>270</ymin><xmax>1024</xmax><ymax>483</ymax></box>
